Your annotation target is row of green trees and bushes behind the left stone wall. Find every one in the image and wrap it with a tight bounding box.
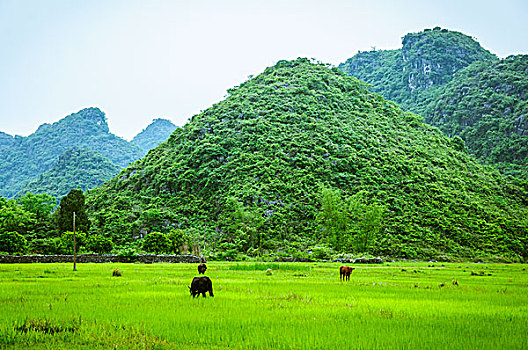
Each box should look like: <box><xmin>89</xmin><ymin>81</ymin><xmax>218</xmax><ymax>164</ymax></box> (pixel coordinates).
<box><xmin>0</xmin><ymin>189</ymin><xmax>189</xmax><ymax>255</ymax></box>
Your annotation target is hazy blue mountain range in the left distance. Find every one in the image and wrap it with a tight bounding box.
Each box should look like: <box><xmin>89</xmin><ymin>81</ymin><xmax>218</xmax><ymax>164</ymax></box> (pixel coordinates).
<box><xmin>0</xmin><ymin>108</ymin><xmax>176</xmax><ymax>197</ymax></box>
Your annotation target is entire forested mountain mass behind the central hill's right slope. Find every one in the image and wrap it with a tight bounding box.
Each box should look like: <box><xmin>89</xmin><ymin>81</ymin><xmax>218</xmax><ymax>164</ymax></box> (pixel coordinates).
<box><xmin>339</xmin><ymin>28</ymin><xmax>528</xmax><ymax>179</ymax></box>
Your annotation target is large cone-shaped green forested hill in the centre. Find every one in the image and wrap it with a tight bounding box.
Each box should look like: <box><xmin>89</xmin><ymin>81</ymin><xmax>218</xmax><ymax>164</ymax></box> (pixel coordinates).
<box><xmin>87</xmin><ymin>59</ymin><xmax>528</xmax><ymax>257</ymax></box>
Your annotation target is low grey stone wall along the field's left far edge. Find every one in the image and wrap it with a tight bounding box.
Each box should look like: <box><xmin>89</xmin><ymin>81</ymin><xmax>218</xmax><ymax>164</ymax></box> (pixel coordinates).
<box><xmin>0</xmin><ymin>254</ymin><xmax>206</xmax><ymax>264</ymax></box>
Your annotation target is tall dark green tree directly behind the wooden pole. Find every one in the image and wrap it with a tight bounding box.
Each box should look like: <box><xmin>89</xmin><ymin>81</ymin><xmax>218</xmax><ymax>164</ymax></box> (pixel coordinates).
<box><xmin>53</xmin><ymin>189</ymin><xmax>90</xmax><ymax>234</ymax></box>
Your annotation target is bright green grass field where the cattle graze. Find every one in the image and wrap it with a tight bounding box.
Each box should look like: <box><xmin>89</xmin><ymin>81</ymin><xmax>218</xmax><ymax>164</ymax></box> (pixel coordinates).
<box><xmin>0</xmin><ymin>263</ymin><xmax>528</xmax><ymax>349</ymax></box>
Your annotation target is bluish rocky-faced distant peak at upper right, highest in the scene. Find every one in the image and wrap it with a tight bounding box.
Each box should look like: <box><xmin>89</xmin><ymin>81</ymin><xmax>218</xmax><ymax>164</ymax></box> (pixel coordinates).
<box><xmin>339</xmin><ymin>27</ymin><xmax>497</xmax><ymax>113</ymax></box>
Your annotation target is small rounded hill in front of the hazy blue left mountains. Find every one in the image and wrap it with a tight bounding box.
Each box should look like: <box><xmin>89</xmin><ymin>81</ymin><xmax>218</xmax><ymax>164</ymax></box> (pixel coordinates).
<box><xmin>20</xmin><ymin>147</ymin><xmax>121</xmax><ymax>199</ymax></box>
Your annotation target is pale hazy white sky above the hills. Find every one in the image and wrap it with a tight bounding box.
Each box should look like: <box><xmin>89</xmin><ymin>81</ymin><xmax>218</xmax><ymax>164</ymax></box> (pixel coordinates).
<box><xmin>0</xmin><ymin>0</ymin><xmax>528</xmax><ymax>139</ymax></box>
